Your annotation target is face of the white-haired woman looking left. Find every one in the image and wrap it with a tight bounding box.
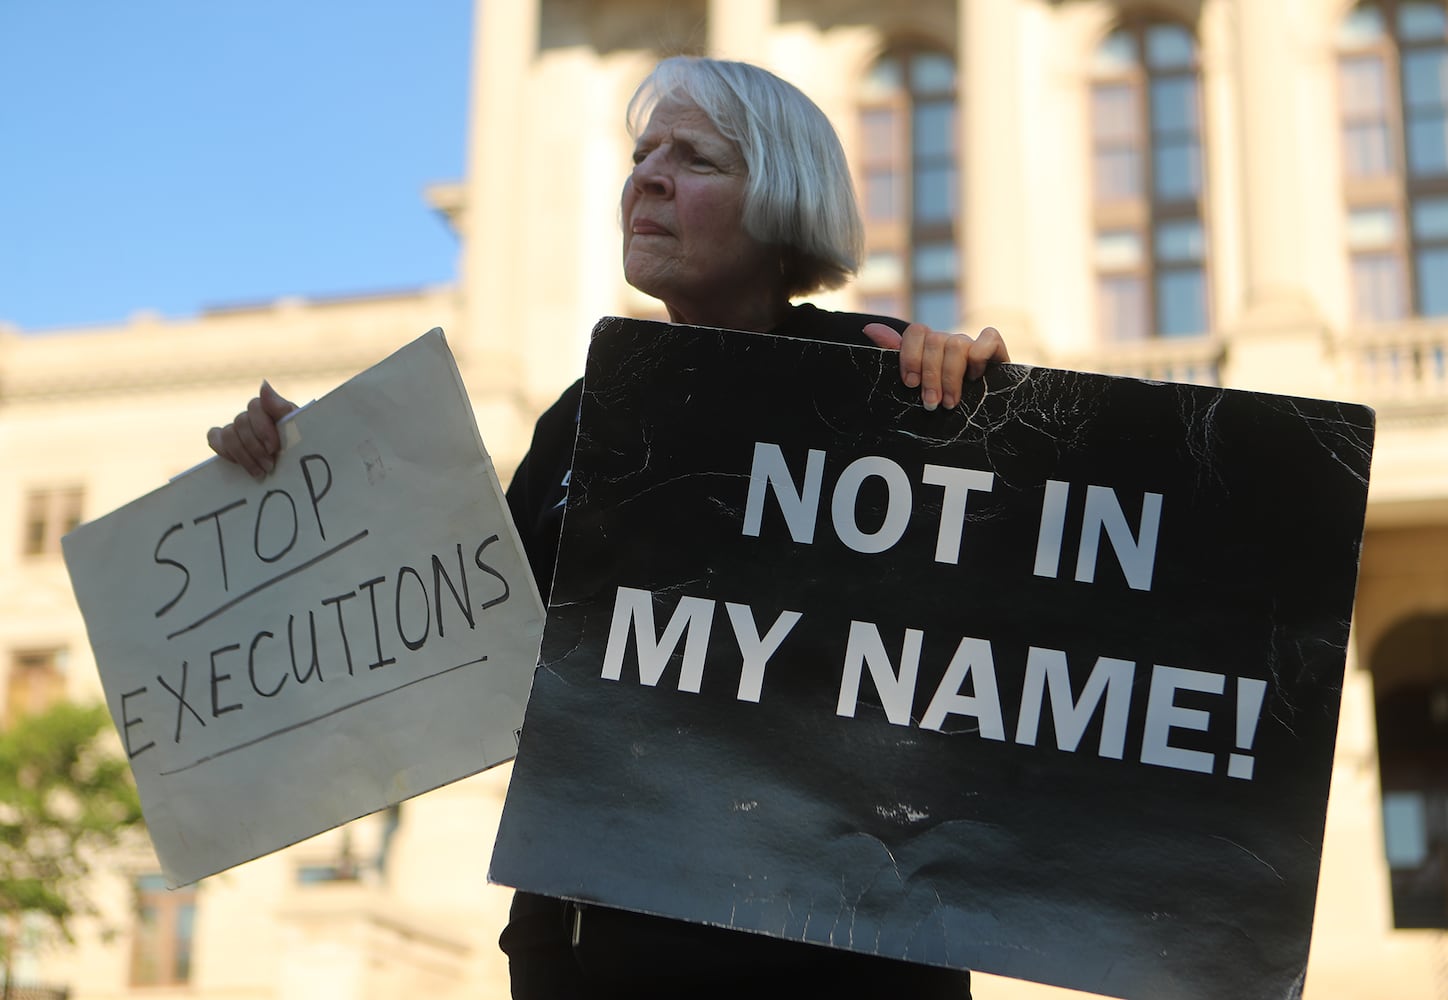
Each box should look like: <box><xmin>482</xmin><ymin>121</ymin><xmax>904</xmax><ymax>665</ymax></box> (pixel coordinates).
<box><xmin>623</xmin><ymin>101</ymin><xmax>780</xmax><ymax>326</ymax></box>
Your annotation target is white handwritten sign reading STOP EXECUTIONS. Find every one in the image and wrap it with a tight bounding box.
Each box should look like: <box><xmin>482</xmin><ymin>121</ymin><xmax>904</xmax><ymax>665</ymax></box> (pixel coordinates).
<box><xmin>64</xmin><ymin>330</ymin><xmax>543</xmax><ymax>886</ymax></box>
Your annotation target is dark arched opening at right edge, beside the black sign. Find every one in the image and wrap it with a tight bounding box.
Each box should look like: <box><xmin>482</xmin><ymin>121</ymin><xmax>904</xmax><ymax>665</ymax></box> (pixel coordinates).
<box><xmin>1373</xmin><ymin>614</ymin><xmax>1448</xmax><ymax>928</ymax></box>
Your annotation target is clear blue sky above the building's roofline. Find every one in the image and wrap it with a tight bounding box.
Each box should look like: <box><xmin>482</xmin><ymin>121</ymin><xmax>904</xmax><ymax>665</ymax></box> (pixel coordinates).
<box><xmin>0</xmin><ymin>0</ymin><xmax>472</xmax><ymax>331</ymax></box>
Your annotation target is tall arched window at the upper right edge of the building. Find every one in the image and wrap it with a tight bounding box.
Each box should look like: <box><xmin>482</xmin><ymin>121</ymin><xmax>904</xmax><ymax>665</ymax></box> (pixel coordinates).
<box><xmin>1338</xmin><ymin>0</ymin><xmax>1448</xmax><ymax>323</ymax></box>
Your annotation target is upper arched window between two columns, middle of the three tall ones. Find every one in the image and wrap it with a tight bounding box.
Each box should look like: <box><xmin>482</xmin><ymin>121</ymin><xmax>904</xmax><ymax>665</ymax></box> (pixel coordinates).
<box><xmin>1092</xmin><ymin>20</ymin><xmax>1208</xmax><ymax>340</ymax></box>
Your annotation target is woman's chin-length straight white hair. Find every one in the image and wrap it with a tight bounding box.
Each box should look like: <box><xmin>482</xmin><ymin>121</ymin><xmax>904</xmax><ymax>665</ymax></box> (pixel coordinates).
<box><xmin>628</xmin><ymin>55</ymin><xmax>864</xmax><ymax>297</ymax></box>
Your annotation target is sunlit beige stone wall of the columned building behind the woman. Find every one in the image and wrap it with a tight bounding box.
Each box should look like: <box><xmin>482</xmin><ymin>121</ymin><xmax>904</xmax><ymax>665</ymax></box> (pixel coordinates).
<box><xmin>8</xmin><ymin>0</ymin><xmax>1448</xmax><ymax>1000</ymax></box>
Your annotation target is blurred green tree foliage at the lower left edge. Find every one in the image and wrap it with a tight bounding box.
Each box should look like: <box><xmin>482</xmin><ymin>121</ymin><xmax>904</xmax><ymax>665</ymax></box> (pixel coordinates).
<box><xmin>0</xmin><ymin>702</ymin><xmax>140</xmax><ymax>964</ymax></box>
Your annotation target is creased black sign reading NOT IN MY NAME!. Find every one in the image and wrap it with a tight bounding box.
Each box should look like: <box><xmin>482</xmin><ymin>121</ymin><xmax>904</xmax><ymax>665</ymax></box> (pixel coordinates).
<box><xmin>492</xmin><ymin>320</ymin><xmax>1373</xmax><ymax>1000</ymax></box>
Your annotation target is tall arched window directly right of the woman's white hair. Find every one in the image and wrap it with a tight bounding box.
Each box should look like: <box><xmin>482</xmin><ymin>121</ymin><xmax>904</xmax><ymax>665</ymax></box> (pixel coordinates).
<box><xmin>859</xmin><ymin>49</ymin><xmax>961</xmax><ymax>330</ymax></box>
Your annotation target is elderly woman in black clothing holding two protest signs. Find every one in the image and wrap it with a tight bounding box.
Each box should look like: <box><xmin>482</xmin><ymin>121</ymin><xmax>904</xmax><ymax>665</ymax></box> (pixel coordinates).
<box><xmin>207</xmin><ymin>56</ymin><xmax>1008</xmax><ymax>999</ymax></box>
